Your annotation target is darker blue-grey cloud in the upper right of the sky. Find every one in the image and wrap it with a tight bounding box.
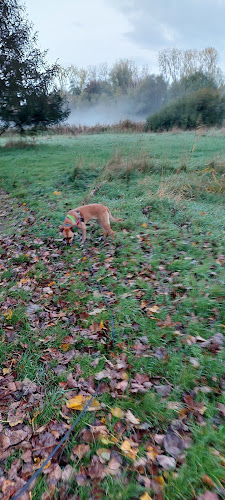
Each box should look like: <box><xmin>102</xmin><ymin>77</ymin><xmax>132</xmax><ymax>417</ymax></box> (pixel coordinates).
<box><xmin>107</xmin><ymin>0</ymin><xmax>225</xmax><ymax>51</ymax></box>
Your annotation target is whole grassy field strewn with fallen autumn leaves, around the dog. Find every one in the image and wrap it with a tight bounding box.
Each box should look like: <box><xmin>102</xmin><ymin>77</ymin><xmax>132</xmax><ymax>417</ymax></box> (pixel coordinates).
<box><xmin>0</xmin><ymin>131</ymin><xmax>225</xmax><ymax>500</ymax></box>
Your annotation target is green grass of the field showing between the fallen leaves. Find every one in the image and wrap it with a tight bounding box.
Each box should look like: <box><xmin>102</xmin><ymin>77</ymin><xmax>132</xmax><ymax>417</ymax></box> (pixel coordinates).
<box><xmin>0</xmin><ymin>130</ymin><xmax>225</xmax><ymax>500</ymax></box>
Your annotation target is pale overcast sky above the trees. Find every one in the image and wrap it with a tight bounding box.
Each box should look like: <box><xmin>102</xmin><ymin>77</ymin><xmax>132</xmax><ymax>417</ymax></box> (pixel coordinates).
<box><xmin>25</xmin><ymin>0</ymin><xmax>225</xmax><ymax>72</ymax></box>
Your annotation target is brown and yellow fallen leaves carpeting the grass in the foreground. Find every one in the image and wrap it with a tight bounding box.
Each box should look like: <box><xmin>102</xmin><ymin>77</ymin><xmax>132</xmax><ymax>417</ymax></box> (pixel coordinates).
<box><xmin>0</xmin><ymin>189</ymin><xmax>225</xmax><ymax>500</ymax></box>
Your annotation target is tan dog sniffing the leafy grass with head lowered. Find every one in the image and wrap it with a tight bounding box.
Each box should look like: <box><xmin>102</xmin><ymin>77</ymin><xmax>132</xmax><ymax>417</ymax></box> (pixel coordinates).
<box><xmin>59</xmin><ymin>203</ymin><xmax>122</xmax><ymax>245</ymax></box>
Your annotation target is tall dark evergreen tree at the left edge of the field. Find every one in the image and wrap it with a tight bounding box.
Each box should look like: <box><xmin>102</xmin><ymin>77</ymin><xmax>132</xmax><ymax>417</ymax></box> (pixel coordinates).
<box><xmin>0</xmin><ymin>0</ymin><xmax>69</xmax><ymax>131</ymax></box>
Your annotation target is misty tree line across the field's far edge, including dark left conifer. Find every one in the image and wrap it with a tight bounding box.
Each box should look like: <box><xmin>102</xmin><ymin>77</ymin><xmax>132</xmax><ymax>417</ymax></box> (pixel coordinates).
<box><xmin>0</xmin><ymin>0</ymin><xmax>224</xmax><ymax>132</ymax></box>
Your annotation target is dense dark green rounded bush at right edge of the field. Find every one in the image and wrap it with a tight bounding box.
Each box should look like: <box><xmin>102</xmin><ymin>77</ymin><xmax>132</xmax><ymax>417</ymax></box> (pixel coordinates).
<box><xmin>145</xmin><ymin>88</ymin><xmax>225</xmax><ymax>132</ymax></box>
